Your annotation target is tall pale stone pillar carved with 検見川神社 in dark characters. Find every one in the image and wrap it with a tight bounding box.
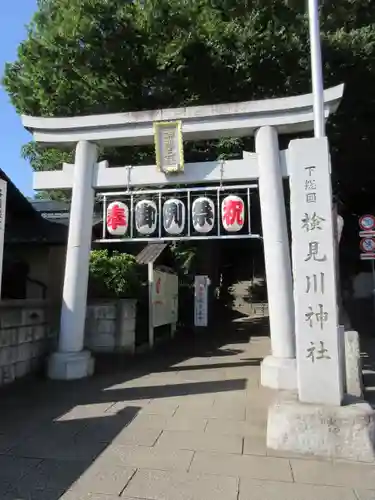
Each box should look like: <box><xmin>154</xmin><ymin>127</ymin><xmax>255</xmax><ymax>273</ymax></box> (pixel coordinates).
<box><xmin>289</xmin><ymin>138</ymin><xmax>343</xmax><ymax>405</ymax></box>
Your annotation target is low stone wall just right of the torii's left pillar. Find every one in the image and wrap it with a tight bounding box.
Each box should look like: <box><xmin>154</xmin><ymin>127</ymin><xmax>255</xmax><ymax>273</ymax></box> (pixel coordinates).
<box><xmin>85</xmin><ymin>299</ymin><xmax>136</xmax><ymax>354</ymax></box>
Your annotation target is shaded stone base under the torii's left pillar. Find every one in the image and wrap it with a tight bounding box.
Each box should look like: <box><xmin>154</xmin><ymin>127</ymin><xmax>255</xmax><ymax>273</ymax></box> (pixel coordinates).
<box><xmin>48</xmin><ymin>351</ymin><xmax>94</xmax><ymax>380</ymax></box>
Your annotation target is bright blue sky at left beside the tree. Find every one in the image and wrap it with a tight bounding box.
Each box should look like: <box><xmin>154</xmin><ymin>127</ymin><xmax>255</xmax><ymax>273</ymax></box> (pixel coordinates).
<box><xmin>0</xmin><ymin>0</ymin><xmax>36</xmax><ymax>196</ymax></box>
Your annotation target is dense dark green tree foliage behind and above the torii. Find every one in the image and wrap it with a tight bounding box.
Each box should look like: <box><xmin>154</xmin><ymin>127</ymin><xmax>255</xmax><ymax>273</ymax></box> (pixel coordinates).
<box><xmin>4</xmin><ymin>0</ymin><xmax>375</xmax><ymax>211</ymax></box>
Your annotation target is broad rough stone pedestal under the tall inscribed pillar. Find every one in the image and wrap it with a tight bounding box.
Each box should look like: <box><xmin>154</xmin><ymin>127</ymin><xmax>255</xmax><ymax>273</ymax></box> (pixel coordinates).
<box><xmin>267</xmin><ymin>392</ymin><xmax>375</xmax><ymax>462</ymax></box>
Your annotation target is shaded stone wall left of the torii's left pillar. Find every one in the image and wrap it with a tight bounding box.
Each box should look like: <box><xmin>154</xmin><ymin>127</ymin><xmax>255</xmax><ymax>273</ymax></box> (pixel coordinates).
<box><xmin>0</xmin><ymin>300</ymin><xmax>58</xmax><ymax>385</ymax></box>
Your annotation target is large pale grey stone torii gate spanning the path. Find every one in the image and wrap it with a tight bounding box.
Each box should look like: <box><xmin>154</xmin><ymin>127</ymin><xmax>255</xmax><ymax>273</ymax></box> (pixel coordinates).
<box><xmin>22</xmin><ymin>85</ymin><xmax>343</xmax><ymax>389</ymax></box>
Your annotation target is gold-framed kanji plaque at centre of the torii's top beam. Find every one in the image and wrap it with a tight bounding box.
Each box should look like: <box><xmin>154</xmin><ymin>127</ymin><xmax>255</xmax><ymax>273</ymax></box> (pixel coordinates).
<box><xmin>154</xmin><ymin>121</ymin><xmax>184</xmax><ymax>174</ymax></box>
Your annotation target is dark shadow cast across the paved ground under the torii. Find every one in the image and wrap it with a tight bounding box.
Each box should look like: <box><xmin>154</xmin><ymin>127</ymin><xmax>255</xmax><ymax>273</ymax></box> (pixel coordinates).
<box><xmin>0</xmin><ymin>314</ymin><xmax>262</xmax><ymax>500</ymax></box>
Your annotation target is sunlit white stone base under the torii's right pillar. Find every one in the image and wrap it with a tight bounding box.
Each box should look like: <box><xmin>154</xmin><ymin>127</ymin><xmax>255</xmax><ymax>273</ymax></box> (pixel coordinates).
<box><xmin>260</xmin><ymin>356</ymin><xmax>297</xmax><ymax>391</ymax></box>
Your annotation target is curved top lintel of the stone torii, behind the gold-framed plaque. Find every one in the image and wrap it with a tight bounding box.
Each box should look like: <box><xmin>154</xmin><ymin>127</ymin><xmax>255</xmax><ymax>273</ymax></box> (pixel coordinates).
<box><xmin>22</xmin><ymin>84</ymin><xmax>344</xmax><ymax>147</ymax></box>
